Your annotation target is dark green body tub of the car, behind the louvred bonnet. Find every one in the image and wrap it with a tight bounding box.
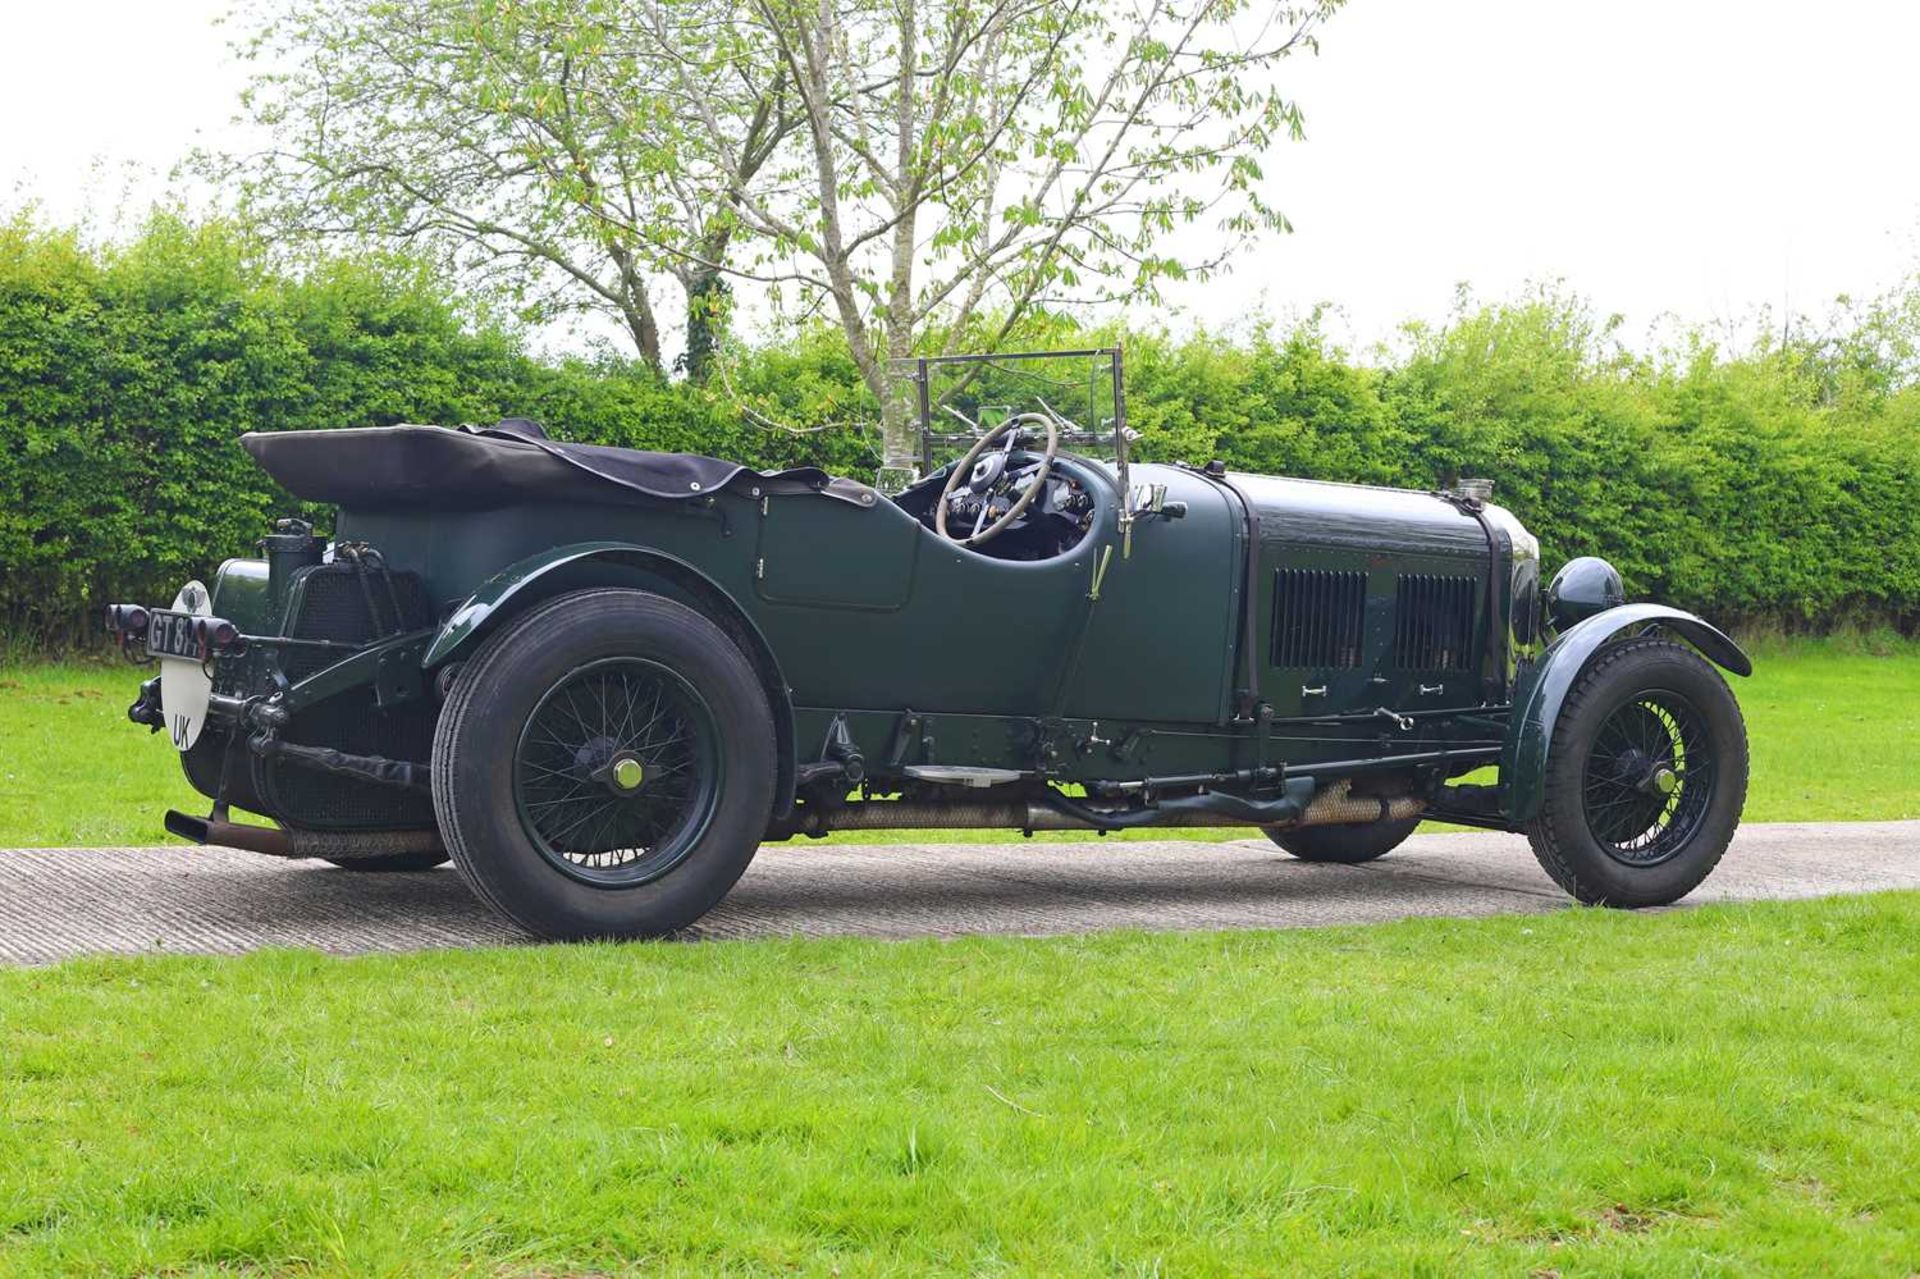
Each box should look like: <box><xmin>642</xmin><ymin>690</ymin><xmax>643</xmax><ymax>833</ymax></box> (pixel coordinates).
<box><xmin>397</xmin><ymin>461</ymin><xmax>1236</xmax><ymax>724</ymax></box>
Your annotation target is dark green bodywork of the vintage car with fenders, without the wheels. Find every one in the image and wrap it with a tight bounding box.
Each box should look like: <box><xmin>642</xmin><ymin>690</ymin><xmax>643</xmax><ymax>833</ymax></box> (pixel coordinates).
<box><xmin>117</xmin><ymin>343</ymin><xmax>1749</xmax><ymax>933</ymax></box>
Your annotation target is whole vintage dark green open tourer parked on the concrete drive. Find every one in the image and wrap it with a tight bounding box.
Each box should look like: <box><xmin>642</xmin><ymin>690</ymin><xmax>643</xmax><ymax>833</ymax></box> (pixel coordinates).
<box><xmin>108</xmin><ymin>350</ymin><xmax>1751</xmax><ymax>937</ymax></box>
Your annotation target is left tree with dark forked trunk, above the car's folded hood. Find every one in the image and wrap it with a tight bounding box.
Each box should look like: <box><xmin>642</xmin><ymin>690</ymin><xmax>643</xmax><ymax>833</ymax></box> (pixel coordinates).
<box><xmin>211</xmin><ymin>0</ymin><xmax>795</xmax><ymax>376</ymax></box>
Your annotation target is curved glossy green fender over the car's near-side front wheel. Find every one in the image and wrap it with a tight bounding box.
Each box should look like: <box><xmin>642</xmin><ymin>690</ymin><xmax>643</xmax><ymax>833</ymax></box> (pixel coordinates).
<box><xmin>1500</xmin><ymin>603</ymin><xmax>1753</xmax><ymax>824</ymax></box>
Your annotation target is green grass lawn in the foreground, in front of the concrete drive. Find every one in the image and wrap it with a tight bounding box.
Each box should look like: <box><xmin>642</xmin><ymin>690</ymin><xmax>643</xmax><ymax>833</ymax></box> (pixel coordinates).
<box><xmin>0</xmin><ymin>893</ymin><xmax>1920</xmax><ymax>1275</ymax></box>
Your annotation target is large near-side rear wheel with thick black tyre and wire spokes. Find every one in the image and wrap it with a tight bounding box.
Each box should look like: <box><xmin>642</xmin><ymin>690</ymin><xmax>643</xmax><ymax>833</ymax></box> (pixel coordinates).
<box><xmin>434</xmin><ymin>590</ymin><xmax>774</xmax><ymax>939</ymax></box>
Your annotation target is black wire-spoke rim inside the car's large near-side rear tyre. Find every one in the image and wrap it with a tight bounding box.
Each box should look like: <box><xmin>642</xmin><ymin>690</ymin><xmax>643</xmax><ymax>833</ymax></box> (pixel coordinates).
<box><xmin>513</xmin><ymin>657</ymin><xmax>720</xmax><ymax>887</ymax></box>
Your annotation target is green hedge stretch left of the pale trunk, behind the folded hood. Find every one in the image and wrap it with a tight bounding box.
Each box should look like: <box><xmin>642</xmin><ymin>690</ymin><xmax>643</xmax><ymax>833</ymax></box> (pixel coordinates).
<box><xmin>0</xmin><ymin>215</ymin><xmax>856</xmax><ymax>647</ymax></box>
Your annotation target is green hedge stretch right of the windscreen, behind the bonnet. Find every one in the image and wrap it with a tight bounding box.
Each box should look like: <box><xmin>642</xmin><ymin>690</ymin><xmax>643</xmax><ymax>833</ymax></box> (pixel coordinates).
<box><xmin>1127</xmin><ymin>307</ymin><xmax>1920</xmax><ymax>630</ymax></box>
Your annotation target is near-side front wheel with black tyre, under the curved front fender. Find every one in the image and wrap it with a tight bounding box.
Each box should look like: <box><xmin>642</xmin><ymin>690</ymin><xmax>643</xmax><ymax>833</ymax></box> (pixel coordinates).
<box><xmin>1526</xmin><ymin>640</ymin><xmax>1747</xmax><ymax>894</ymax></box>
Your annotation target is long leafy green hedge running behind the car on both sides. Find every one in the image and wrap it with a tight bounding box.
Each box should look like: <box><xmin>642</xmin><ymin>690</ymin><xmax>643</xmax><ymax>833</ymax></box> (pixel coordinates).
<box><xmin>0</xmin><ymin>219</ymin><xmax>1920</xmax><ymax>647</ymax></box>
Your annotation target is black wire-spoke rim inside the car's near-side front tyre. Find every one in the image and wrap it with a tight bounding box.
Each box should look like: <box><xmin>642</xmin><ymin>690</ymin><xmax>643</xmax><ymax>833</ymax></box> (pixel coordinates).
<box><xmin>1580</xmin><ymin>689</ymin><xmax>1715</xmax><ymax>866</ymax></box>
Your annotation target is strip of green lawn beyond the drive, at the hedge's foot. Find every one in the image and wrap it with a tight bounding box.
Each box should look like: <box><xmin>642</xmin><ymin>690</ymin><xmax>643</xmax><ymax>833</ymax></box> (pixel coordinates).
<box><xmin>0</xmin><ymin>643</ymin><xmax>1920</xmax><ymax>847</ymax></box>
